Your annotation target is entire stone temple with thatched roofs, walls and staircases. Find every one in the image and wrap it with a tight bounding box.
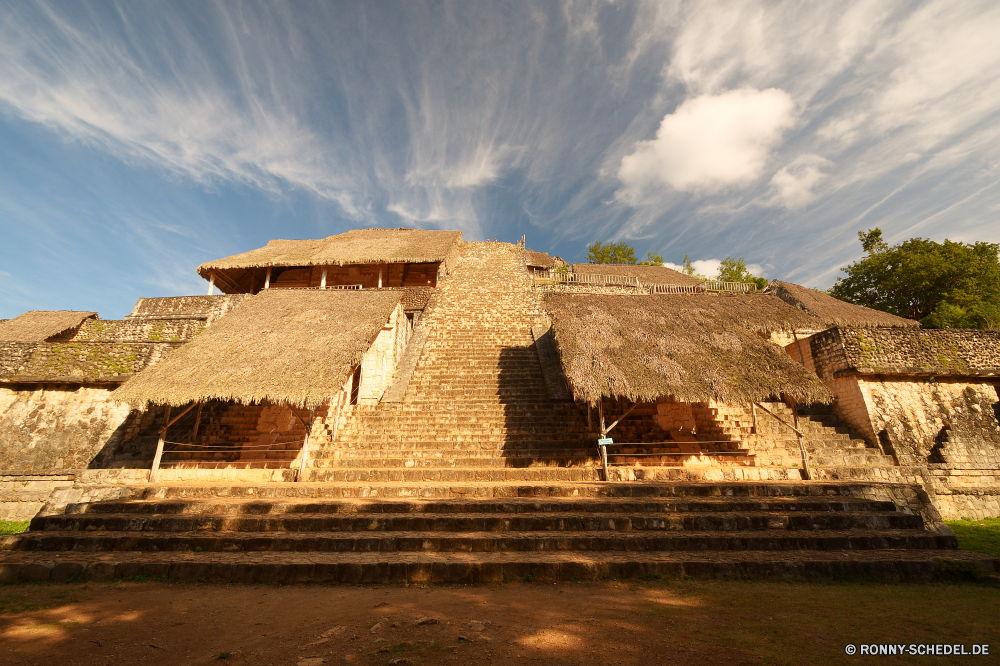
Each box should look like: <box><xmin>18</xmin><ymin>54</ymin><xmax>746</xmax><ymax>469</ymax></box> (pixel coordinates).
<box><xmin>0</xmin><ymin>229</ymin><xmax>1000</xmax><ymax>582</ymax></box>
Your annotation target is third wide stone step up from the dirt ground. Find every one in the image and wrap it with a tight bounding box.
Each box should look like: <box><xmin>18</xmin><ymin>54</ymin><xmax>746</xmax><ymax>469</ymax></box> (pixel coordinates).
<box><xmin>28</xmin><ymin>512</ymin><xmax>923</xmax><ymax>537</ymax></box>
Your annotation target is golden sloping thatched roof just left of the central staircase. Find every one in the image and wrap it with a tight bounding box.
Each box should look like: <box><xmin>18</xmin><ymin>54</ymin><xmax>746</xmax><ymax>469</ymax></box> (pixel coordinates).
<box><xmin>113</xmin><ymin>289</ymin><xmax>402</xmax><ymax>407</ymax></box>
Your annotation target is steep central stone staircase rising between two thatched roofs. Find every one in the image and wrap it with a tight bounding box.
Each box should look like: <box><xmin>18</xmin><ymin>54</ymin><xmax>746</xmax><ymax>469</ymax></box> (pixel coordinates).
<box><xmin>306</xmin><ymin>243</ymin><xmax>600</xmax><ymax>482</ymax></box>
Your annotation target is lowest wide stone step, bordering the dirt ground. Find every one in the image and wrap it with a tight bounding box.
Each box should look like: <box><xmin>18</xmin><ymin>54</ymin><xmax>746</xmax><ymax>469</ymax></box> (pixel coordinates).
<box><xmin>0</xmin><ymin>549</ymin><xmax>1000</xmax><ymax>584</ymax></box>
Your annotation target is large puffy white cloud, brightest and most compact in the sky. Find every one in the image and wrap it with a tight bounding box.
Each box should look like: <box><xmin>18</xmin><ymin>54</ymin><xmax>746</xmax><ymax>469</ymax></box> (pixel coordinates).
<box><xmin>618</xmin><ymin>88</ymin><xmax>795</xmax><ymax>202</ymax></box>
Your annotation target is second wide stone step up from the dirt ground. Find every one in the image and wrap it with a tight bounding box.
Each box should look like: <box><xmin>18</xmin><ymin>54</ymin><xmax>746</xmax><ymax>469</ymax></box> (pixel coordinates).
<box><xmin>0</xmin><ymin>529</ymin><xmax>958</xmax><ymax>553</ymax></box>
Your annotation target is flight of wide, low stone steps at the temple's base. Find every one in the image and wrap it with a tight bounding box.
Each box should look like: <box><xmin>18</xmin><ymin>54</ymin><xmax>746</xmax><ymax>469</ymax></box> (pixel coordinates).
<box><xmin>0</xmin><ymin>482</ymin><xmax>998</xmax><ymax>583</ymax></box>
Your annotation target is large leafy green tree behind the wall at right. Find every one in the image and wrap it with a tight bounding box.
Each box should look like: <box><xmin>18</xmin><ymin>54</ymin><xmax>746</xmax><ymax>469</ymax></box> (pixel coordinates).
<box><xmin>829</xmin><ymin>227</ymin><xmax>1000</xmax><ymax>328</ymax></box>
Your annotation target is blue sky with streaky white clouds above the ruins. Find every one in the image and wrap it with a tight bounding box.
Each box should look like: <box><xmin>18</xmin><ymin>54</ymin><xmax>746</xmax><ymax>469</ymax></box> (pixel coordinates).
<box><xmin>0</xmin><ymin>0</ymin><xmax>1000</xmax><ymax>318</ymax></box>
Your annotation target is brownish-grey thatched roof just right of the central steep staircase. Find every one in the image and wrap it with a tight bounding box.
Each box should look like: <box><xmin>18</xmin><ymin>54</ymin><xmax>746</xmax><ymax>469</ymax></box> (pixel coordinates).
<box><xmin>543</xmin><ymin>293</ymin><xmax>832</xmax><ymax>403</ymax></box>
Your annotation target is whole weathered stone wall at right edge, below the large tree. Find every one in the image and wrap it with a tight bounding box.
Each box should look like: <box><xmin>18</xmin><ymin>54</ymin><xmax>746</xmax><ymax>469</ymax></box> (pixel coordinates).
<box><xmin>800</xmin><ymin>329</ymin><xmax>1000</xmax><ymax>519</ymax></box>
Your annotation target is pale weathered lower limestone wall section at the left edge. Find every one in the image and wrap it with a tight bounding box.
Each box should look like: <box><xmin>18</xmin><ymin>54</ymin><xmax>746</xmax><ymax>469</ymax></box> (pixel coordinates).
<box><xmin>0</xmin><ymin>384</ymin><xmax>131</xmax><ymax>473</ymax></box>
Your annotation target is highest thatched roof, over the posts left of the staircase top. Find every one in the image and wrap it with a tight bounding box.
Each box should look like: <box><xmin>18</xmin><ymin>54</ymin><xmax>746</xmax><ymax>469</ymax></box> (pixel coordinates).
<box><xmin>198</xmin><ymin>229</ymin><xmax>462</xmax><ymax>277</ymax></box>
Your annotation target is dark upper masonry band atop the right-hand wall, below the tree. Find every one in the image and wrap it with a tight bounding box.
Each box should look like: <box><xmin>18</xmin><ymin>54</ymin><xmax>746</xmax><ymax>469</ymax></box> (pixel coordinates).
<box><xmin>809</xmin><ymin>328</ymin><xmax>1000</xmax><ymax>377</ymax></box>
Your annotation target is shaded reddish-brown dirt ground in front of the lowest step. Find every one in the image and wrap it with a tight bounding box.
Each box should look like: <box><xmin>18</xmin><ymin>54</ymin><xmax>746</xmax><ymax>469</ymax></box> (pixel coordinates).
<box><xmin>0</xmin><ymin>581</ymin><xmax>1000</xmax><ymax>666</ymax></box>
